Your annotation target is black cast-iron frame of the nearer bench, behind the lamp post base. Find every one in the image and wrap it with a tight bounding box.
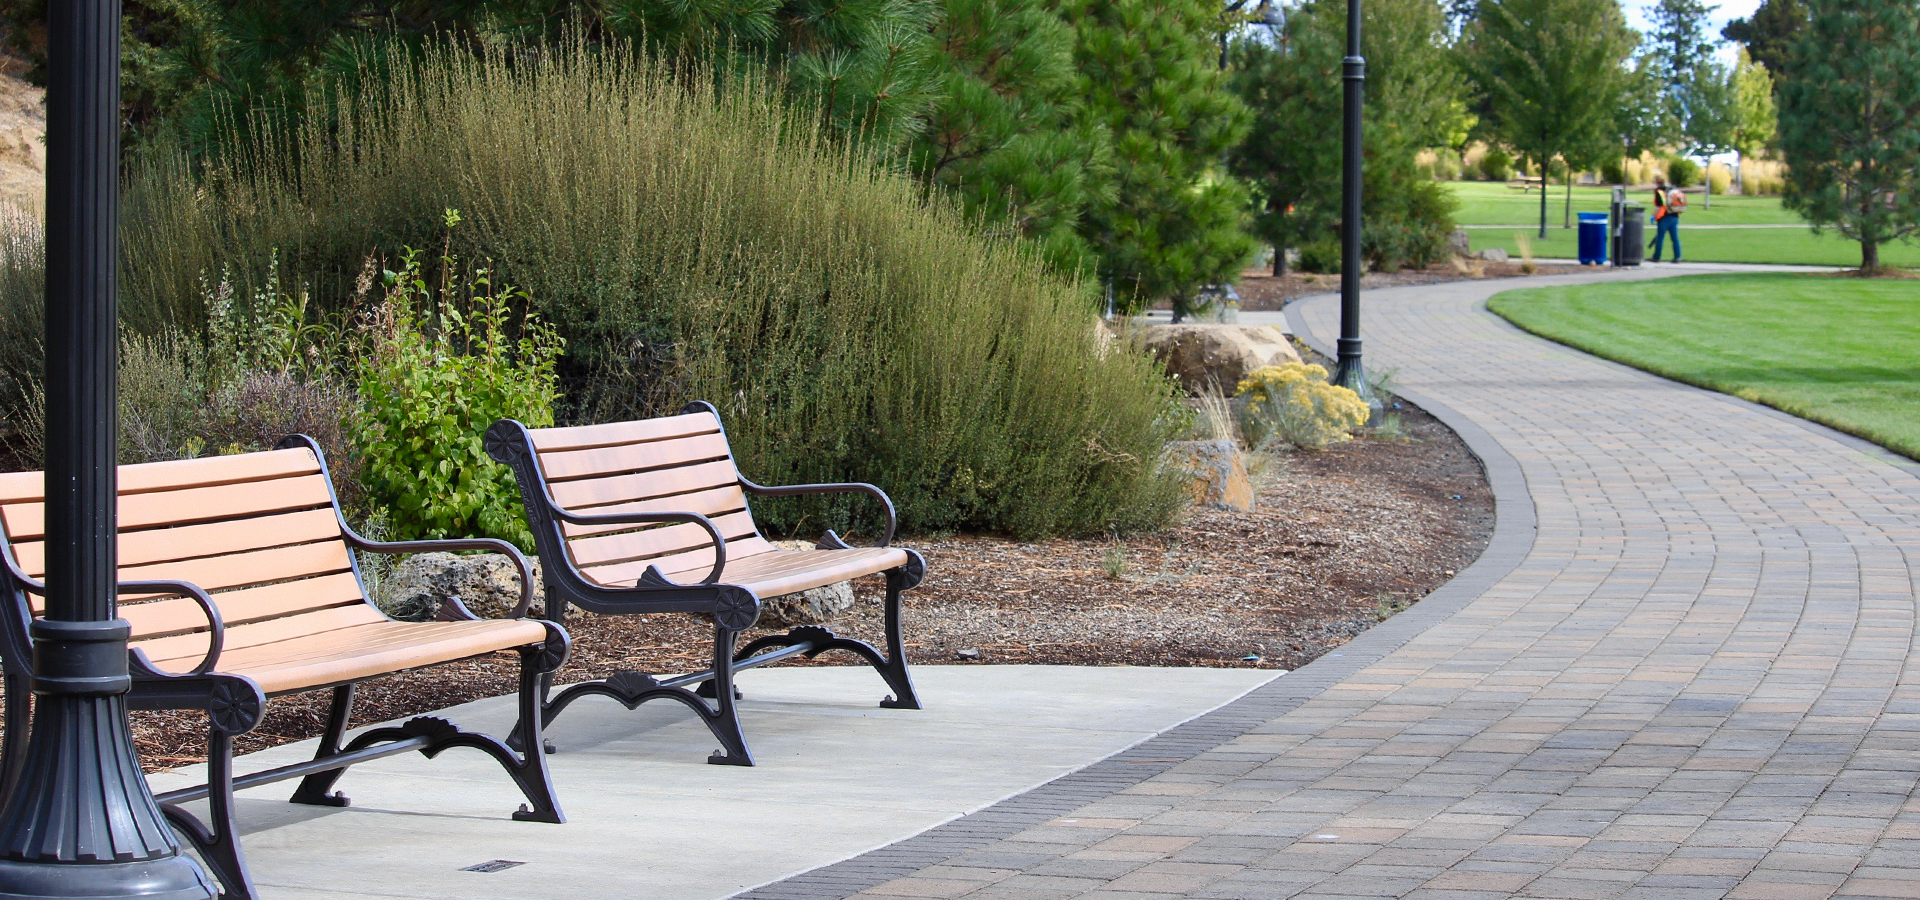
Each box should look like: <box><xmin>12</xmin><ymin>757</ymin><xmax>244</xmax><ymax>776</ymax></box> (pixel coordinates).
<box><xmin>0</xmin><ymin>436</ymin><xmax>570</xmax><ymax>900</ymax></box>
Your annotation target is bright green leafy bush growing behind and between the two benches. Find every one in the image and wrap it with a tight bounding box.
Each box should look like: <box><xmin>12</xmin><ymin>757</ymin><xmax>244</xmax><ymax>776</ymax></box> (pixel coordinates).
<box><xmin>353</xmin><ymin>235</ymin><xmax>564</xmax><ymax>551</ymax></box>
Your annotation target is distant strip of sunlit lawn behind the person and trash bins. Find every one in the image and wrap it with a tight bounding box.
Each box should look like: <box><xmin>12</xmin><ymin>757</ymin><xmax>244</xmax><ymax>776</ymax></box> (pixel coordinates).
<box><xmin>1448</xmin><ymin>180</ymin><xmax>1920</xmax><ymax>267</ymax></box>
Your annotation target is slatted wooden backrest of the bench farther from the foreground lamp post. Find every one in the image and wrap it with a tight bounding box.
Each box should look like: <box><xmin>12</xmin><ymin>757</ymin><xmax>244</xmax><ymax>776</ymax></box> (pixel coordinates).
<box><xmin>528</xmin><ymin>411</ymin><xmax>774</xmax><ymax>585</ymax></box>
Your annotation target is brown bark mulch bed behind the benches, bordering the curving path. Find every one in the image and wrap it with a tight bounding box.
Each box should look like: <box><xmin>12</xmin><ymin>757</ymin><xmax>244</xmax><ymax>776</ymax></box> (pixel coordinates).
<box><xmin>3</xmin><ymin>391</ymin><xmax>1494</xmax><ymax>770</ymax></box>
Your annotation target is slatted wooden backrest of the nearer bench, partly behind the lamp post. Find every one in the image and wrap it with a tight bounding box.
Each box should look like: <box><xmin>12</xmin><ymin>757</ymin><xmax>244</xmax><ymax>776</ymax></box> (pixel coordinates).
<box><xmin>0</xmin><ymin>447</ymin><xmax>369</xmax><ymax>672</ymax></box>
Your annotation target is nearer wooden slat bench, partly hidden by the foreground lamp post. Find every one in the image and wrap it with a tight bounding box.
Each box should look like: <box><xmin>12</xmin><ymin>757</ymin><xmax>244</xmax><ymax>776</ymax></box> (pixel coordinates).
<box><xmin>0</xmin><ymin>436</ymin><xmax>568</xmax><ymax>898</ymax></box>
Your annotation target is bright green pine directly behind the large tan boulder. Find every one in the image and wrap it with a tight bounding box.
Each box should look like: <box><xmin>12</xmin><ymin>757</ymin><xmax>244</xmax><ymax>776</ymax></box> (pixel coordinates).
<box><xmin>1062</xmin><ymin>0</ymin><xmax>1254</xmax><ymax>315</ymax></box>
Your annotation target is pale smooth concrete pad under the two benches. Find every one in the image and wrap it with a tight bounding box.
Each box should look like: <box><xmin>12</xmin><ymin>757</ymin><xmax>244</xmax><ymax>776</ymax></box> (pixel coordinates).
<box><xmin>150</xmin><ymin>666</ymin><xmax>1277</xmax><ymax>900</ymax></box>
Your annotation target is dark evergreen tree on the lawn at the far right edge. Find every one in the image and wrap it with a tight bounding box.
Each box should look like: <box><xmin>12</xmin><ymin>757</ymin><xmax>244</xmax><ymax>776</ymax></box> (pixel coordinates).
<box><xmin>1780</xmin><ymin>0</ymin><xmax>1920</xmax><ymax>274</ymax></box>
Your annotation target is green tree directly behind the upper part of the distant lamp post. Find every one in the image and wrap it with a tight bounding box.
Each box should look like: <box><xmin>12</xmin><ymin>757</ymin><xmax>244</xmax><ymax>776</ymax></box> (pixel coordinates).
<box><xmin>1231</xmin><ymin>0</ymin><xmax>1467</xmax><ymax>272</ymax></box>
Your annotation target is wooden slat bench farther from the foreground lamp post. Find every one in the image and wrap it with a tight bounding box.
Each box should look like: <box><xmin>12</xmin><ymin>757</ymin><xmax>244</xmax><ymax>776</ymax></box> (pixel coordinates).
<box><xmin>486</xmin><ymin>403</ymin><xmax>927</xmax><ymax>766</ymax></box>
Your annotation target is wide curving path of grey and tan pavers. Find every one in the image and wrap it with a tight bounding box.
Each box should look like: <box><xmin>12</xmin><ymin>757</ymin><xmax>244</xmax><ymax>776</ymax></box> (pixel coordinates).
<box><xmin>741</xmin><ymin>272</ymin><xmax>1920</xmax><ymax>900</ymax></box>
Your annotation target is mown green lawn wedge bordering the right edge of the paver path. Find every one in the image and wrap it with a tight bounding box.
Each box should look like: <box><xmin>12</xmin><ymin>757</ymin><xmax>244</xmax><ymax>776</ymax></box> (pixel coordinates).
<box><xmin>1488</xmin><ymin>274</ymin><xmax>1920</xmax><ymax>459</ymax></box>
